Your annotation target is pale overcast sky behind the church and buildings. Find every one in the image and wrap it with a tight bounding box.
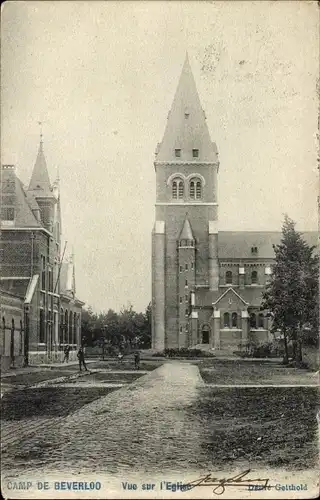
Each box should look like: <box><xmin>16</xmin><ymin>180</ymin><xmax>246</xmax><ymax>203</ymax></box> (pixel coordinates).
<box><xmin>2</xmin><ymin>1</ymin><xmax>319</xmax><ymax>311</ymax></box>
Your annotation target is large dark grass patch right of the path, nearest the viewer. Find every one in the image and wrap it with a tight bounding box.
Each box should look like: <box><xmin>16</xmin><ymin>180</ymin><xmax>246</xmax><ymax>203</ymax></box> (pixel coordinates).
<box><xmin>188</xmin><ymin>387</ymin><xmax>318</xmax><ymax>469</ymax></box>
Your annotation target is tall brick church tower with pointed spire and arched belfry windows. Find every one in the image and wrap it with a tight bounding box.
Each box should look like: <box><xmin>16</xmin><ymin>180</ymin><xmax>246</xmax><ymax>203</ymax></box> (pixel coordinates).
<box><xmin>152</xmin><ymin>56</ymin><xmax>219</xmax><ymax>350</ymax></box>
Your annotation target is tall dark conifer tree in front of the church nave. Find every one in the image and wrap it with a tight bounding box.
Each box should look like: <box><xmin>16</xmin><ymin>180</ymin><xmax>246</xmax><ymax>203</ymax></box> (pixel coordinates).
<box><xmin>261</xmin><ymin>215</ymin><xmax>318</xmax><ymax>363</ymax></box>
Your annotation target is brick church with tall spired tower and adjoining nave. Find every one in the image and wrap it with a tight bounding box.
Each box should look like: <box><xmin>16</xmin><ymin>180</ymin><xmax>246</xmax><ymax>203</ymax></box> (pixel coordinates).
<box><xmin>152</xmin><ymin>54</ymin><xmax>317</xmax><ymax>349</ymax></box>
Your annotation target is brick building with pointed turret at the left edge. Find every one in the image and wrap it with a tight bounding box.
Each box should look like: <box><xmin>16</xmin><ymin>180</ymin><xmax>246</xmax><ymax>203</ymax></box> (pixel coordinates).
<box><xmin>0</xmin><ymin>139</ymin><xmax>83</xmax><ymax>366</ymax></box>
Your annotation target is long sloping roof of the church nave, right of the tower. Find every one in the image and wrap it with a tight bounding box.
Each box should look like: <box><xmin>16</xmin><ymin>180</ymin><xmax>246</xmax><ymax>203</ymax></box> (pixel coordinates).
<box><xmin>218</xmin><ymin>231</ymin><xmax>318</xmax><ymax>259</ymax></box>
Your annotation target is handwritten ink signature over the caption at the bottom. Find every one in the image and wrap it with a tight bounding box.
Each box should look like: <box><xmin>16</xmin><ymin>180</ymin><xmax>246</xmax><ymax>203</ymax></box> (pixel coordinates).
<box><xmin>185</xmin><ymin>469</ymin><xmax>271</xmax><ymax>495</ymax></box>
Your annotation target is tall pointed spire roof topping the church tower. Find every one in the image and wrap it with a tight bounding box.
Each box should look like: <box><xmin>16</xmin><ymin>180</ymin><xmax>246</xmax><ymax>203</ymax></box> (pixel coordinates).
<box><xmin>156</xmin><ymin>54</ymin><xmax>217</xmax><ymax>162</ymax></box>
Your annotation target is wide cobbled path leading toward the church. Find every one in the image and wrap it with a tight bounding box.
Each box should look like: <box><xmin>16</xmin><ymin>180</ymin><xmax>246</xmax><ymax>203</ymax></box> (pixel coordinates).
<box><xmin>2</xmin><ymin>362</ymin><xmax>204</xmax><ymax>474</ymax></box>
